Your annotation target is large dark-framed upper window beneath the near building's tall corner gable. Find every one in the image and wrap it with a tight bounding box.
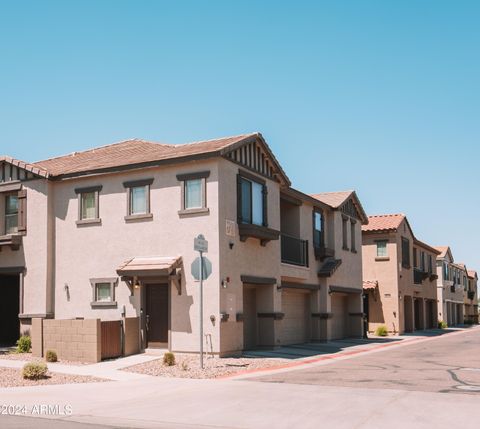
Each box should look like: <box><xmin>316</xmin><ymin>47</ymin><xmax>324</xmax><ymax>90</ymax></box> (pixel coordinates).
<box><xmin>237</xmin><ymin>172</ymin><xmax>268</xmax><ymax>227</ymax></box>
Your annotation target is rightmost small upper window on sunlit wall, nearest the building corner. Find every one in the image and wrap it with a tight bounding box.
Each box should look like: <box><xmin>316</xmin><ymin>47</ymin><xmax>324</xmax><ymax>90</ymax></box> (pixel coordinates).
<box><xmin>177</xmin><ymin>171</ymin><xmax>210</xmax><ymax>214</ymax></box>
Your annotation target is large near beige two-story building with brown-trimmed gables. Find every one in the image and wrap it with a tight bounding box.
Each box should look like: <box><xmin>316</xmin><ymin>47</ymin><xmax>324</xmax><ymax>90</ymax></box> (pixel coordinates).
<box><xmin>0</xmin><ymin>133</ymin><xmax>367</xmax><ymax>359</ymax></box>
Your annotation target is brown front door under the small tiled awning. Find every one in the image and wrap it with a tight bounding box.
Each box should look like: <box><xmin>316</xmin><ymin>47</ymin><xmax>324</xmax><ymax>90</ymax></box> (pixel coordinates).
<box><xmin>147</xmin><ymin>284</ymin><xmax>169</xmax><ymax>347</ymax></box>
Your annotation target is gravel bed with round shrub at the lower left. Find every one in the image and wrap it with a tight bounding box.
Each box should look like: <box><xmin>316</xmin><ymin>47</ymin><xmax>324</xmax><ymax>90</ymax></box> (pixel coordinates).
<box><xmin>0</xmin><ymin>367</ymin><xmax>108</xmax><ymax>387</ymax></box>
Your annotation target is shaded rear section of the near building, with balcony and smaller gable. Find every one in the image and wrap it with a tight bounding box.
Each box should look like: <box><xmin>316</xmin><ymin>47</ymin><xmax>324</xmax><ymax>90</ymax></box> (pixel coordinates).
<box><xmin>280</xmin><ymin>189</ymin><xmax>367</xmax><ymax>342</ymax></box>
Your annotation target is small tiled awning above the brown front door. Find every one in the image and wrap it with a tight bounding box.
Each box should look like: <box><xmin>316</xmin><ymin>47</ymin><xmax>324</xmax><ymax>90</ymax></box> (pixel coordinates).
<box><xmin>117</xmin><ymin>256</ymin><xmax>182</xmax><ymax>277</ymax></box>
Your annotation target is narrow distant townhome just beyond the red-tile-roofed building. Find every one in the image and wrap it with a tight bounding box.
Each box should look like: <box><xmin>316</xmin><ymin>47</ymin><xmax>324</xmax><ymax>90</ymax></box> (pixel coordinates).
<box><xmin>435</xmin><ymin>246</ymin><xmax>466</xmax><ymax>326</ymax></box>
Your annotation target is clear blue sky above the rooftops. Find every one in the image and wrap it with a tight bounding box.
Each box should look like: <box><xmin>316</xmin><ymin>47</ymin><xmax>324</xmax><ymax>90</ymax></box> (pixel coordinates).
<box><xmin>0</xmin><ymin>0</ymin><xmax>480</xmax><ymax>269</ymax></box>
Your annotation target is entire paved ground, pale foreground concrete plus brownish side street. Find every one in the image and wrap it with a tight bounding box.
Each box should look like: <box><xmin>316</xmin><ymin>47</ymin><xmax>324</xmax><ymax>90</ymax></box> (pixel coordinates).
<box><xmin>0</xmin><ymin>328</ymin><xmax>480</xmax><ymax>429</ymax></box>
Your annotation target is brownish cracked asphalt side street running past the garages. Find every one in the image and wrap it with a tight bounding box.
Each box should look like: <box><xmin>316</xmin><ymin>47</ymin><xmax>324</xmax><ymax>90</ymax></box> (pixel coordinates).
<box><xmin>252</xmin><ymin>329</ymin><xmax>480</xmax><ymax>397</ymax></box>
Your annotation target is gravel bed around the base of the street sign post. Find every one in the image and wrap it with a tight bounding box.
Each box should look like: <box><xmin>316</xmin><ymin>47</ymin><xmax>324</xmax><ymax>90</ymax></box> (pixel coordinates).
<box><xmin>123</xmin><ymin>354</ymin><xmax>289</xmax><ymax>378</ymax></box>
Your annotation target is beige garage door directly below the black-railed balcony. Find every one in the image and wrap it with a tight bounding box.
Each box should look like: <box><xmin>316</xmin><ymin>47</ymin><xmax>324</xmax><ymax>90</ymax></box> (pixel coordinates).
<box><xmin>281</xmin><ymin>290</ymin><xmax>310</xmax><ymax>344</ymax></box>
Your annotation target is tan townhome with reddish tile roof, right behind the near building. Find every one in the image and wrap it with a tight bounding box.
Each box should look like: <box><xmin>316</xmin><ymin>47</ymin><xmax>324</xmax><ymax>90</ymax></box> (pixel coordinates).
<box><xmin>362</xmin><ymin>214</ymin><xmax>439</xmax><ymax>334</ymax></box>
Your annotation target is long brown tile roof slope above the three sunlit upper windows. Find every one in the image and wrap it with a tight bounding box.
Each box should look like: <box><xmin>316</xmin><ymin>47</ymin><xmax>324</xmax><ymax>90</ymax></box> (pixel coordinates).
<box><xmin>33</xmin><ymin>133</ymin><xmax>261</xmax><ymax>176</ymax></box>
